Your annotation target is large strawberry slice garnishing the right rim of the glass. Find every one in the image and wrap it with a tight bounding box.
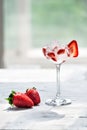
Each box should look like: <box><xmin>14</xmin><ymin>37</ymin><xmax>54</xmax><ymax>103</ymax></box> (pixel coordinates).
<box><xmin>67</xmin><ymin>40</ymin><xmax>78</xmax><ymax>57</ymax></box>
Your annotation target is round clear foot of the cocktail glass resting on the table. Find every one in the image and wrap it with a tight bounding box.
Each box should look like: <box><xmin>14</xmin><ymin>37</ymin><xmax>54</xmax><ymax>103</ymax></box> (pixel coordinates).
<box><xmin>45</xmin><ymin>98</ymin><xmax>72</xmax><ymax>106</ymax></box>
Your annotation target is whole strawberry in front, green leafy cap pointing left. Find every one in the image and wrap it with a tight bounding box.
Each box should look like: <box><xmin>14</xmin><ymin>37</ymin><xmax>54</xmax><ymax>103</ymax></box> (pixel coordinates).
<box><xmin>7</xmin><ymin>91</ymin><xmax>34</xmax><ymax>108</ymax></box>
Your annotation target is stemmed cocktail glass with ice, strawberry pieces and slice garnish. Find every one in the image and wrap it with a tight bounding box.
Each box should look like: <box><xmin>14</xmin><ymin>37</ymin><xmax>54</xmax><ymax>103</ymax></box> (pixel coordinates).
<box><xmin>42</xmin><ymin>40</ymin><xmax>78</xmax><ymax>106</ymax></box>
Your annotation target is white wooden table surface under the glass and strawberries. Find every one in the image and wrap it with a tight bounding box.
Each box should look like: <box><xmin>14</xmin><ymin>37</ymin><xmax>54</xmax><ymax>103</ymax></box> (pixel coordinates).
<box><xmin>0</xmin><ymin>65</ymin><xmax>87</xmax><ymax>130</ymax></box>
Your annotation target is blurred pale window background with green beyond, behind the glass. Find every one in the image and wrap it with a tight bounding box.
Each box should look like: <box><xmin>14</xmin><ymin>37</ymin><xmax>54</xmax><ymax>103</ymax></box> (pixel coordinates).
<box><xmin>0</xmin><ymin>0</ymin><xmax>87</xmax><ymax>68</ymax></box>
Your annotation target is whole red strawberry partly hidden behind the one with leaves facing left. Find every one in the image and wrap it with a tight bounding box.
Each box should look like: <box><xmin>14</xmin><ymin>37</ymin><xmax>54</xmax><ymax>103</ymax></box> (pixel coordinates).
<box><xmin>26</xmin><ymin>87</ymin><xmax>41</xmax><ymax>105</ymax></box>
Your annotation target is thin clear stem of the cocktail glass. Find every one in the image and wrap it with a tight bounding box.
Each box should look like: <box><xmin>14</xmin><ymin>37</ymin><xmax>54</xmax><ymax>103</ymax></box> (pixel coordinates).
<box><xmin>56</xmin><ymin>64</ymin><xmax>61</xmax><ymax>98</ymax></box>
